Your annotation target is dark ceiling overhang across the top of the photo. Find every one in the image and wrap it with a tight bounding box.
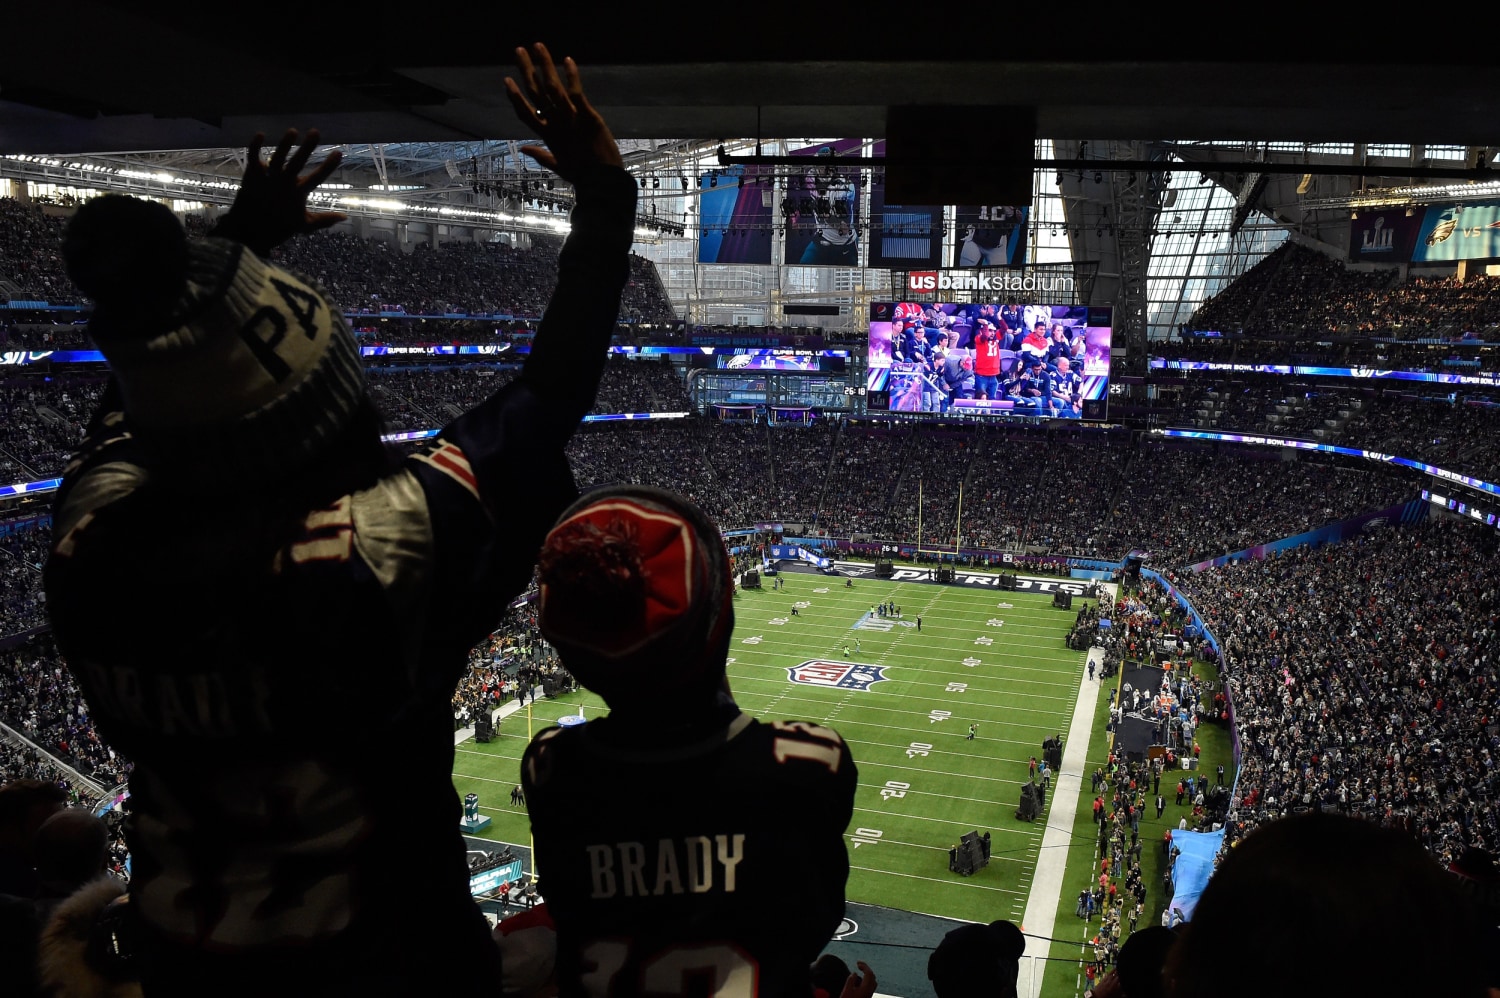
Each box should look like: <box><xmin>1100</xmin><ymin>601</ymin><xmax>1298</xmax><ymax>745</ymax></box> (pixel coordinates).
<box><xmin>0</xmin><ymin>8</ymin><xmax>1500</xmax><ymax>156</ymax></box>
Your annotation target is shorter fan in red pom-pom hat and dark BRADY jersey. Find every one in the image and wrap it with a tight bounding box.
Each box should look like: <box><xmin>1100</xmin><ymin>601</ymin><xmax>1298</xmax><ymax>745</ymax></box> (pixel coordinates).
<box><xmin>522</xmin><ymin>486</ymin><xmax>857</xmax><ymax>998</ymax></box>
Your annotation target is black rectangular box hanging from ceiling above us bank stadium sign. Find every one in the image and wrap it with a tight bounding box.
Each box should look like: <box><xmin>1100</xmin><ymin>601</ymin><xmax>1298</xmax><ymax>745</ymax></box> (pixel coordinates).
<box><xmin>885</xmin><ymin>105</ymin><xmax>1037</xmax><ymax>206</ymax></box>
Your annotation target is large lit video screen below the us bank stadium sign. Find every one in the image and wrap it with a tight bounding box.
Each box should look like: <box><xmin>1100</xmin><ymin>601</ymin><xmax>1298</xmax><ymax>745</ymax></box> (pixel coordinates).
<box><xmin>866</xmin><ymin>302</ymin><xmax>1113</xmax><ymax>420</ymax></box>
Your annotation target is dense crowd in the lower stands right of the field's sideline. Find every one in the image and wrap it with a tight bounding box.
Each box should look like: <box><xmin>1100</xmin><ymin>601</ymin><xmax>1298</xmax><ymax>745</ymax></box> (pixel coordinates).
<box><xmin>1179</xmin><ymin>521</ymin><xmax>1500</xmax><ymax>864</ymax></box>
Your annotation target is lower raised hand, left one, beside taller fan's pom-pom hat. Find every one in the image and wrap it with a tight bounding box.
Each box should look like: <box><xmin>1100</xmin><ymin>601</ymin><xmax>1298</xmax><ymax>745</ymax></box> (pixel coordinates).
<box><xmin>218</xmin><ymin>129</ymin><xmax>347</xmax><ymax>254</ymax></box>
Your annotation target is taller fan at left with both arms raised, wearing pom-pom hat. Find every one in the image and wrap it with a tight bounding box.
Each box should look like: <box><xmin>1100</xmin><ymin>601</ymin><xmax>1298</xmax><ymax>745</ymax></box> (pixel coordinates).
<box><xmin>45</xmin><ymin>45</ymin><xmax>635</xmax><ymax>998</ymax></box>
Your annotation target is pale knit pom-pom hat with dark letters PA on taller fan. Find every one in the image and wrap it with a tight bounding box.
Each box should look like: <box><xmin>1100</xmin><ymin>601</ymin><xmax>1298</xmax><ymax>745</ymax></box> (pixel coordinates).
<box><xmin>63</xmin><ymin>195</ymin><xmax>365</xmax><ymax>480</ymax></box>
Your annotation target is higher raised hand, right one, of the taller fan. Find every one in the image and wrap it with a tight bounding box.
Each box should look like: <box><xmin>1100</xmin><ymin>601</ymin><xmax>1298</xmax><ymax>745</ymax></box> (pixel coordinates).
<box><xmin>506</xmin><ymin>42</ymin><xmax>624</xmax><ymax>182</ymax></box>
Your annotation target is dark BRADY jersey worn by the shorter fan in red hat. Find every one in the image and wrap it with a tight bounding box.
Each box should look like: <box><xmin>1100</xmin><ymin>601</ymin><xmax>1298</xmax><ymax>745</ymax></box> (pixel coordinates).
<box><xmin>522</xmin><ymin>711</ymin><xmax>857</xmax><ymax>998</ymax></box>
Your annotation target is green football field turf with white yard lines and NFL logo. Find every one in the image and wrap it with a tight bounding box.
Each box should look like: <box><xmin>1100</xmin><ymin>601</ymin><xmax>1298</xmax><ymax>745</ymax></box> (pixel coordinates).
<box><xmin>453</xmin><ymin>573</ymin><xmax>1085</xmax><ymax>921</ymax></box>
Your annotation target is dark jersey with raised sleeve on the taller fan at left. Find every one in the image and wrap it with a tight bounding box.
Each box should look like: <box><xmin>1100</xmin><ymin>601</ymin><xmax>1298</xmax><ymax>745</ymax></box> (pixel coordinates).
<box><xmin>45</xmin><ymin>168</ymin><xmax>635</xmax><ymax>993</ymax></box>
